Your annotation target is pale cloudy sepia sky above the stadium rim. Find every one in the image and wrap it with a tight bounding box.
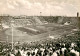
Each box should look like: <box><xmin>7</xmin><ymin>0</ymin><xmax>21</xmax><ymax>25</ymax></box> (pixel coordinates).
<box><xmin>0</xmin><ymin>0</ymin><xmax>80</xmax><ymax>16</ymax></box>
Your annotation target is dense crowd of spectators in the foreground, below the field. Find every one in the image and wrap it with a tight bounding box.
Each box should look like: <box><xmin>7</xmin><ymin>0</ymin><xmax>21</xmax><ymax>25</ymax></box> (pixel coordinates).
<box><xmin>0</xmin><ymin>31</ymin><xmax>80</xmax><ymax>56</ymax></box>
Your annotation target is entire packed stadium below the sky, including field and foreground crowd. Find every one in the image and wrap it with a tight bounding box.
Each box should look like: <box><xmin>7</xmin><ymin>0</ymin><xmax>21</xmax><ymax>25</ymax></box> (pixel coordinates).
<box><xmin>0</xmin><ymin>16</ymin><xmax>80</xmax><ymax>56</ymax></box>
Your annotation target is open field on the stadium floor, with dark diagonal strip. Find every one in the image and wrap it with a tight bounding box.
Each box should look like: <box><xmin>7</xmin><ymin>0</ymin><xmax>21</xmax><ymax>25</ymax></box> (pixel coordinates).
<box><xmin>0</xmin><ymin>24</ymin><xmax>75</xmax><ymax>42</ymax></box>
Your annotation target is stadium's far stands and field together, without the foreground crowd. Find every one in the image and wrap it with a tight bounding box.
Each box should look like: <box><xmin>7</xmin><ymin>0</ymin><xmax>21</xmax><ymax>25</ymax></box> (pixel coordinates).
<box><xmin>0</xmin><ymin>16</ymin><xmax>77</xmax><ymax>42</ymax></box>
